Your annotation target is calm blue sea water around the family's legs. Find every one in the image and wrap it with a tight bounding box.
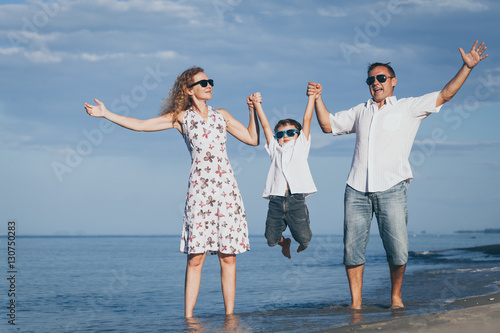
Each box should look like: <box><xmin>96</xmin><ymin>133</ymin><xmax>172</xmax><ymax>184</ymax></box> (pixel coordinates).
<box><xmin>0</xmin><ymin>234</ymin><xmax>500</xmax><ymax>333</ymax></box>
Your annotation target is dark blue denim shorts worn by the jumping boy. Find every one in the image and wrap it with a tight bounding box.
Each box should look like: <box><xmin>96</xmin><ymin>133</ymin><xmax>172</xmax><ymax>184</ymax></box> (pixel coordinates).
<box><xmin>265</xmin><ymin>191</ymin><xmax>312</xmax><ymax>246</ymax></box>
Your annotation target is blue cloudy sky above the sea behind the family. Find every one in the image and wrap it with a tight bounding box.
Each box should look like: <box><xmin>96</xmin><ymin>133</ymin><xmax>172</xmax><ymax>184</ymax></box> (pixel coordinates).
<box><xmin>0</xmin><ymin>0</ymin><xmax>500</xmax><ymax>235</ymax></box>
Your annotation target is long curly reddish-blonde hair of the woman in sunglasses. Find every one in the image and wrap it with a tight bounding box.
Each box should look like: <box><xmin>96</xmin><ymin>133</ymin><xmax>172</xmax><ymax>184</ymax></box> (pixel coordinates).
<box><xmin>161</xmin><ymin>66</ymin><xmax>204</xmax><ymax>119</ymax></box>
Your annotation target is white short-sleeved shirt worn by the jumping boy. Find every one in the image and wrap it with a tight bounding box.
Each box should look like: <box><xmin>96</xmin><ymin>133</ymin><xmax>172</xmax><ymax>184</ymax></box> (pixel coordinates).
<box><xmin>262</xmin><ymin>133</ymin><xmax>317</xmax><ymax>199</ymax></box>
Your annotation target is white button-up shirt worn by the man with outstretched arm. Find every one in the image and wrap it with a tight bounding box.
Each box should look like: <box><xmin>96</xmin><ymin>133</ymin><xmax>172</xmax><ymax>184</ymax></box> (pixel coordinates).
<box><xmin>330</xmin><ymin>92</ymin><xmax>441</xmax><ymax>192</ymax></box>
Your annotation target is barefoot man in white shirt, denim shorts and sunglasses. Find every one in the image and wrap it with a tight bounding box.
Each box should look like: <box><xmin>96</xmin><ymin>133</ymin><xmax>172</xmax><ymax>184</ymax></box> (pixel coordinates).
<box><xmin>308</xmin><ymin>41</ymin><xmax>488</xmax><ymax>309</ymax></box>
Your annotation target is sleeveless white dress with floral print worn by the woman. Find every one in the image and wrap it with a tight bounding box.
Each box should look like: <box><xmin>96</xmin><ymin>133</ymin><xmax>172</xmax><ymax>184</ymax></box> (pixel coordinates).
<box><xmin>180</xmin><ymin>106</ymin><xmax>250</xmax><ymax>254</ymax></box>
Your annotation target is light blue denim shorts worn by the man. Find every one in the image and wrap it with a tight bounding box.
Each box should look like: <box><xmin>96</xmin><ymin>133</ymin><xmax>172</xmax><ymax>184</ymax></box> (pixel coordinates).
<box><xmin>344</xmin><ymin>181</ymin><xmax>409</xmax><ymax>266</ymax></box>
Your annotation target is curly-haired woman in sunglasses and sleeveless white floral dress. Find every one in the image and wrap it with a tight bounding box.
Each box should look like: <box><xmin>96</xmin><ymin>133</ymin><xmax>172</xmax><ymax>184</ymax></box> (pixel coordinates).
<box><xmin>85</xmin><ymin>67</ymin><xmax>259</xmax><ymax>318</ymax></box>
